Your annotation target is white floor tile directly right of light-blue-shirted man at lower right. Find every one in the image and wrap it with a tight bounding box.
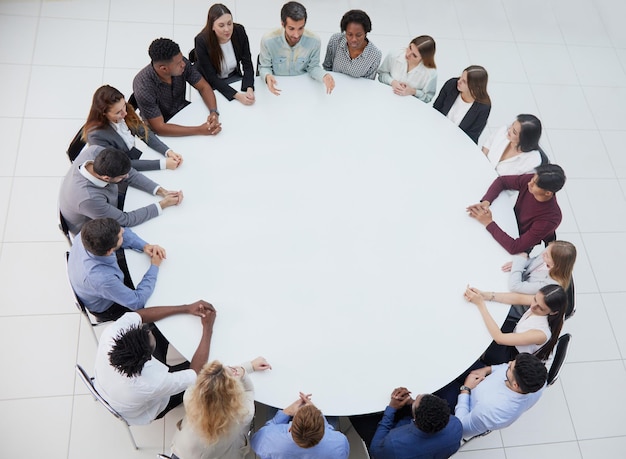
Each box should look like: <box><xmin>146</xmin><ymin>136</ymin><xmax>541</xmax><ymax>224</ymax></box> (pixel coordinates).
<box><xmin>501</xmin><ymin>381</ymin><xmax>576</xmax><ymax>448</ymax></box>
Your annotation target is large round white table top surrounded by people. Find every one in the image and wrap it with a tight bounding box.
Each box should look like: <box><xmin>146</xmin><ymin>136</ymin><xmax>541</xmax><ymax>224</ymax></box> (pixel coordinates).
<box><xmin>126</xmin><ymin>74</ymin><xmax>517</xmax><ymax>415</ymax></box>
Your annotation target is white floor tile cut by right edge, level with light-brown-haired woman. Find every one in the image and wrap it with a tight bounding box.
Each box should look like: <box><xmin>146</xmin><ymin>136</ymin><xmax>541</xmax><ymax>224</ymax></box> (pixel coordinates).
<box><xmin>583</xmin><ymin>233</ymin><xmax>626</xmax><ymax>292</ymax></box>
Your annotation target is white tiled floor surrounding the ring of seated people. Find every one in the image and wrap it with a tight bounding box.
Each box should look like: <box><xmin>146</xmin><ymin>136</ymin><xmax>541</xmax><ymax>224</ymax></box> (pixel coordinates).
<box><xmin>0</xmin><ymin>0</ymin><xmax>626</xmax><ymax>459</ymax></box>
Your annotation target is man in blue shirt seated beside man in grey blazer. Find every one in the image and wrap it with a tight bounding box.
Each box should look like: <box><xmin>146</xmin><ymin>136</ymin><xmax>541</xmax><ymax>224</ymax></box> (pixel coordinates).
<box><xmin>67</xmin><ymin>218</ymin><xmax>165</xmax><ymax>322</ymax></box>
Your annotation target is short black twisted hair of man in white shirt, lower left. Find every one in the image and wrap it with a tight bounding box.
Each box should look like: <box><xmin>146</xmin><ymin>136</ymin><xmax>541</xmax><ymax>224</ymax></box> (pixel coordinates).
<box><xmin>109</xmin><ymin>325</ymin><xmax>152</xmax><ymax>378</ymax></box>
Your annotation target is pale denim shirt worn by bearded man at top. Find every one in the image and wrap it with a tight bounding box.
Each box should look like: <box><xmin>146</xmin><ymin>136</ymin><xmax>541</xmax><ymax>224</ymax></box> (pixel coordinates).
<box><xmin>259</xmin><ymin>28</ymin><xmax>326</xmax><ymax>82</ymax></box>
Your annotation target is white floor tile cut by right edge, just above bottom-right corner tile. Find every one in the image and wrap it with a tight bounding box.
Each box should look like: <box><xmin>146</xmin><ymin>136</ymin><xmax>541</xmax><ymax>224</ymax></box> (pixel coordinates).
<box><xmin>560</xmin><ymin>360</ymin><xmax>626</xmax><ymax>440</ymax></box>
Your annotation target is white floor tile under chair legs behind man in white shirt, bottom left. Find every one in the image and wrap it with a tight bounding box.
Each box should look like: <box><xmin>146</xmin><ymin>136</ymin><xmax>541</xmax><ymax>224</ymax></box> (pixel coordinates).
<box><xmin>67</xmin><ymin>395</ymin><xmax>163</xmax><ymax>459</ymax></box>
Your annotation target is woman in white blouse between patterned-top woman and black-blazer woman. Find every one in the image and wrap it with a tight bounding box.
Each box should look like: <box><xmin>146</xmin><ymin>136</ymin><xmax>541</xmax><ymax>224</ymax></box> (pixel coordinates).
<box><xmin>378</xmin><ymin>35</ymin><xmax>437</xmax><ymax>102</ymax></box>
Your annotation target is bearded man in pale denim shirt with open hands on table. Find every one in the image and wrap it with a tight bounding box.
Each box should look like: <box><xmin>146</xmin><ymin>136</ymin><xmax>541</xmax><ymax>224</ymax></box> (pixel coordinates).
<box><xmin>259</xmin><ymin>2</ymin><xmax>335</xmax><ymax>95</ymax></box>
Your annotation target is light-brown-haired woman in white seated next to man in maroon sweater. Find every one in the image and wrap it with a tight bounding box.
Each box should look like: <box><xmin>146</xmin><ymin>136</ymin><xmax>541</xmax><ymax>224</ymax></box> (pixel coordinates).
<box><xmin>502</xmin><ymin>241</ymin><xmax>576</xmax><ymax>295</ymax></box>
